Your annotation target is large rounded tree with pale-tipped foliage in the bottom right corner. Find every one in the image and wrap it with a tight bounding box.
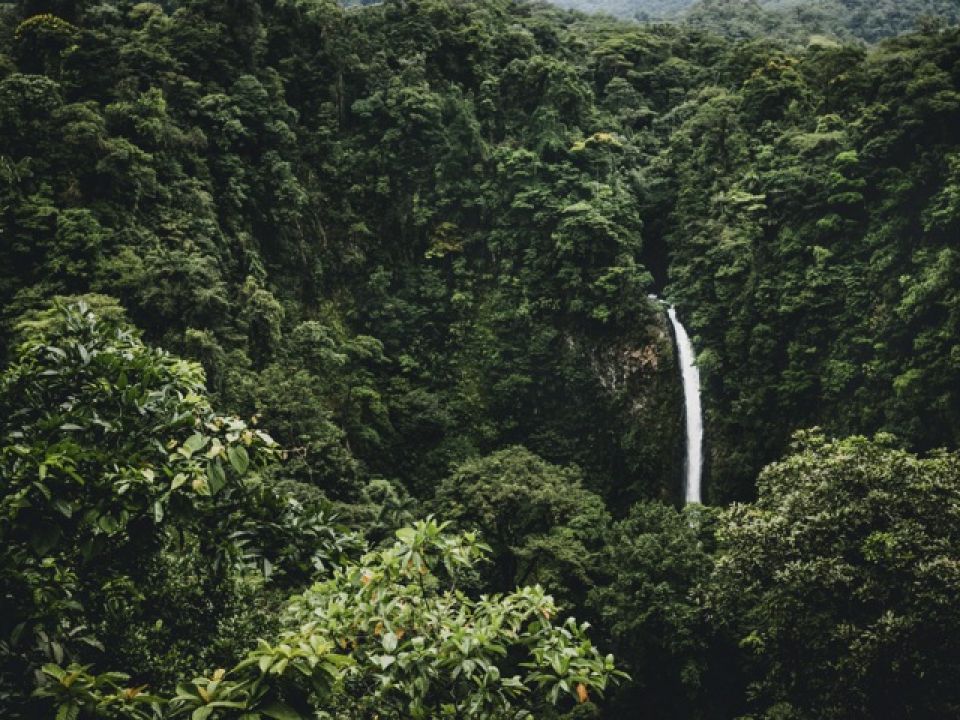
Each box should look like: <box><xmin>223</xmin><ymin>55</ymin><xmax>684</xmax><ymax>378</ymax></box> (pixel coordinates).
<box><xmin>709</xmin><ymin>432</ymin><xmax>960</xmax><ymax>718</ymax></box>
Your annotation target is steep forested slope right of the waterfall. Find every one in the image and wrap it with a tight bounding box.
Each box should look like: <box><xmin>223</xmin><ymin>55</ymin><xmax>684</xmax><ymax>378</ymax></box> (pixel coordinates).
<box><xmin>656</xmin><ymin>25</ymin><xmax>960</xmax><ymax>499</ymax></box>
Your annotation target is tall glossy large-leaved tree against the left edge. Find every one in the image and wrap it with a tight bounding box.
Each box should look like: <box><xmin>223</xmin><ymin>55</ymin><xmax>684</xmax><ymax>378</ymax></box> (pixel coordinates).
<box><xmin>0</xmin><ymin>304</ymin><xmax>278</xmax><ymax>704</ymax></box>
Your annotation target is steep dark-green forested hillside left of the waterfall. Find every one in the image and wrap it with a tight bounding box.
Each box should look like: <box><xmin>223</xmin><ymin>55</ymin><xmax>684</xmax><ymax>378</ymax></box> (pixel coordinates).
<box><xmin>0</xmin><ymin>3</ymin><xmax>688</xmax><ymax>510</ymax></box>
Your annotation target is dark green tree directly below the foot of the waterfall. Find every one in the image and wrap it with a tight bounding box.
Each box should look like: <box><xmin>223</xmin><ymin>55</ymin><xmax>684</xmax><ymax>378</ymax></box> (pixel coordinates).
<box><xmin>588</xmin><ymin>503</ymin><xmax>716</xmax><ymax>718</ymax></box>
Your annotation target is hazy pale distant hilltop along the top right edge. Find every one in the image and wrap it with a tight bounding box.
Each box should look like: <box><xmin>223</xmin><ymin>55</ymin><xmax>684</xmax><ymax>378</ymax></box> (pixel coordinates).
<box><xmin>558</xmin><ymin>0</ymin><xmax>960</xmax><ymax>42</ymax></box>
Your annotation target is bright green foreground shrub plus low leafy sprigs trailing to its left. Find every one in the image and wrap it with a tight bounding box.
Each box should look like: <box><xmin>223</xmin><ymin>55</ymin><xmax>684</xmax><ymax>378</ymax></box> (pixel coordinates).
<box><xmin>37</xmin><ymin>519</ymin><xmax>625</xmax><ymax>720</ymax></box>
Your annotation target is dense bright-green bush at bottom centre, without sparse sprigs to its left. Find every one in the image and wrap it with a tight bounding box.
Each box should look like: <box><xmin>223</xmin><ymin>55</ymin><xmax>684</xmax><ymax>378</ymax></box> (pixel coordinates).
<box><xmin>278</xmin><ymin>520</ymin><xmax>622</xmax><ymax>718</ymax></box>
